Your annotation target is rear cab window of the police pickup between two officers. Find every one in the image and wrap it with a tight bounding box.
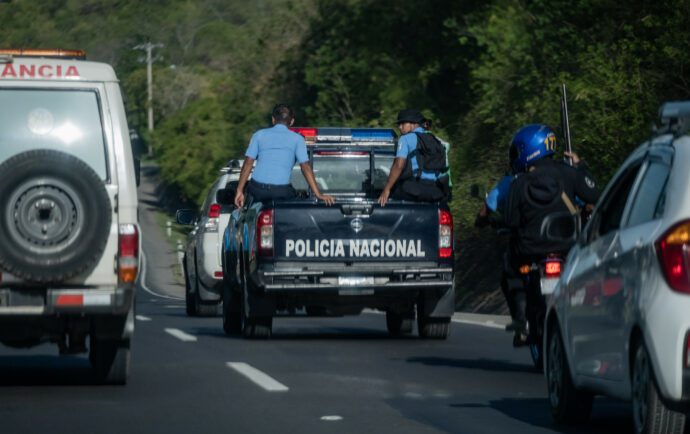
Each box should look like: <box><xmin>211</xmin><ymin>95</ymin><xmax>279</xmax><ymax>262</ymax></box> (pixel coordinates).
<box><xmin>291</xmin><ymin>152</ymin><xmax>394</xmax><ymax>194</ymax></box>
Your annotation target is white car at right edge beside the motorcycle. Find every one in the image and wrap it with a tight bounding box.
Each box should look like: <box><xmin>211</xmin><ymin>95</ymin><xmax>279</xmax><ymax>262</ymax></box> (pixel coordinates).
<box><xmin>544</xmin><ymin>102</ymin><xmax>690</xmax><ymax>433</ymax></box>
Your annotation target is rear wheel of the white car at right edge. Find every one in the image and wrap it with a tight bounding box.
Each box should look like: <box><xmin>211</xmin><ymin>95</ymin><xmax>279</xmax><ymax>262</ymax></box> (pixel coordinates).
<box><xmin>631</xmin><ymin>342</ymin><xmax>685</xmax><ymax>434</ymax></box>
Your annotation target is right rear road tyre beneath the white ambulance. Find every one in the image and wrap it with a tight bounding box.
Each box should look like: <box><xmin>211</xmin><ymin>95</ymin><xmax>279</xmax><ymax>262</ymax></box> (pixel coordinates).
<box><xmin>89</xmin><ymin>336</ymin><xmax>130</xmax><ymax>385</ymax></box>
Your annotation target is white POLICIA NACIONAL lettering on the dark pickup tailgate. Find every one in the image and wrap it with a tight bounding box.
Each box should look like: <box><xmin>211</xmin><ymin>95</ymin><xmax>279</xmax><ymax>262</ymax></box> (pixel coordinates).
<box><xmin>285</xmin><ymin>240</ymin><xmax>426</xmax><ymax>258</ymax></box>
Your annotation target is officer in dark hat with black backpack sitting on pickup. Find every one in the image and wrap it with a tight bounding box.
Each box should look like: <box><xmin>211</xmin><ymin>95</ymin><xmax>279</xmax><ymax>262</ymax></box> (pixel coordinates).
<box><xmin>378</xmin><ymin>109</ymin><xmax>447</xmax><ymax>206</ymax></box>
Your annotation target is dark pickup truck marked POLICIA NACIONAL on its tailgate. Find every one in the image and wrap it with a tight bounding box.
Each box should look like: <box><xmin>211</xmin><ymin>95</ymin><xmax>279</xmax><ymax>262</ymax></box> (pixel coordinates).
<box><xmin>223</xmin><ymin>128</ymin><xmax>455</xmax><ymax>339</ymax></box>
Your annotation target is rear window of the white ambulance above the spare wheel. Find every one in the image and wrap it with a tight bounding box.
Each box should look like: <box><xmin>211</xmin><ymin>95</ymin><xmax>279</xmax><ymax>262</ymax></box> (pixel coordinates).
<box><xmin>0</xmin><ymin>88</ymin><xmax>107</xmax><ymax>180</ymax></box>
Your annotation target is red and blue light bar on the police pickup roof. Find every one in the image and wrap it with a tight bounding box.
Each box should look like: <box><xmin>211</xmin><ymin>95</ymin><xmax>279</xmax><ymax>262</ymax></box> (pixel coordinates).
<box><xmin>290</xmin><ymin>127</ymin><xmax>396</xmax><ymax>146</ymax></box>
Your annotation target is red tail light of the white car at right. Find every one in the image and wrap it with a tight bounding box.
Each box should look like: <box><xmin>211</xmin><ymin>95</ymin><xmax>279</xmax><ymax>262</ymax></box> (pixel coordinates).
<box><xmin>656</xmin><ymin>220</ymin><xmax>690</xmax><ymax>294</ymax></box>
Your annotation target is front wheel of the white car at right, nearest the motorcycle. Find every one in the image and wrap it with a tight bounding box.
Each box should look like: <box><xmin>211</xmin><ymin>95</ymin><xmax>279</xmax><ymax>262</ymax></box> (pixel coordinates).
<box><xmin>546</xmin><ymin>325</ymin><xmax>594</xmax><ymax>424</ymax></box>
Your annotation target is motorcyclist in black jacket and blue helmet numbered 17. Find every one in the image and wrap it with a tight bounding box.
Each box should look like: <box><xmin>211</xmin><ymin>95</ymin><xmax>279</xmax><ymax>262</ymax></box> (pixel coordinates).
<box><xmin>505</xmin><ymin>124</ymin><xmax>599</xmax><ymax>337</ymax></box>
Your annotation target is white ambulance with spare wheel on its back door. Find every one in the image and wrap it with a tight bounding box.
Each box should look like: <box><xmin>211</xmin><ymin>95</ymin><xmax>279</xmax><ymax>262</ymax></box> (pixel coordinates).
<box><xmin>0</xmin><ymin>50</ymin><xmax>139</xmax><ymax>384</ymax></box>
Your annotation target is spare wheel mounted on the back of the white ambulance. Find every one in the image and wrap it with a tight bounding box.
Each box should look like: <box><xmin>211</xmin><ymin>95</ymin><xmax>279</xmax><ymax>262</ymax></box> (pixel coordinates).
<box><xmin>0</xmin><ymin>149</ymin><xmax>112</xmax><ymax>284</ymax></box>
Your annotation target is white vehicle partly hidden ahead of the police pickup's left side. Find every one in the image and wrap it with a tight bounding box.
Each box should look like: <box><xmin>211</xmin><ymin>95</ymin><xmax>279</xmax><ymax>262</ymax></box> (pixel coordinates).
<box><xmin>177</xmin><ymin>160</ymin><xmax>244</xmax><ymax>316</ymax></box>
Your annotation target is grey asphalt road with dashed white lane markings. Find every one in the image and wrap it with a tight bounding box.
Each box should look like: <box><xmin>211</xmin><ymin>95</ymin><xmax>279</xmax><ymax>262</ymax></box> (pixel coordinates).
<box><xmin>0</xmin><ymin>167</ymin><xmax>632</xmax><ymax>434</ymax></box>
